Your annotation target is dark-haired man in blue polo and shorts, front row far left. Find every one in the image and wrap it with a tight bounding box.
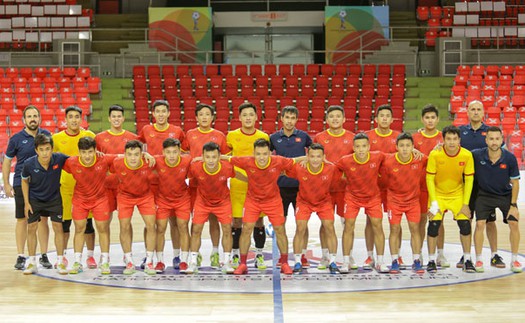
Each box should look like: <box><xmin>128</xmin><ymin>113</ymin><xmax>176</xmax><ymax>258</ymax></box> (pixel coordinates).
<box><xmin>22</xmin><ymin>134</ymin><xmax>69</xmax><ymax>275</ymax></box>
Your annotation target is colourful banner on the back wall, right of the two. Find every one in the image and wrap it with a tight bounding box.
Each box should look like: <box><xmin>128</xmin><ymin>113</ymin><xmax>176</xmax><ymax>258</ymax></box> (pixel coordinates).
<box><xmin>325</xmin><ymin>6</ymin><xmax>390</xmax><ymax>64</ymax></box>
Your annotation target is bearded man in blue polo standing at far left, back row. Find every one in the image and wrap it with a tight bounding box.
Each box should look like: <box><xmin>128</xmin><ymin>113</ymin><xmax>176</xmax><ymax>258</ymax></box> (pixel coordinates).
<box><xmin>2</xmin><ymin>105</ymin><xmax>52</xmax><ymax>270</ymax></box>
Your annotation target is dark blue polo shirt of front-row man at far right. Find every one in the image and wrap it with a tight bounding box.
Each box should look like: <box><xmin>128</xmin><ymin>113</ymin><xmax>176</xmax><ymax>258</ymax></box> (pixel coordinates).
<box><xmin>472</xmin><ymin>148</ymin><xmax>520</xmax><ymax>195</ymax></box>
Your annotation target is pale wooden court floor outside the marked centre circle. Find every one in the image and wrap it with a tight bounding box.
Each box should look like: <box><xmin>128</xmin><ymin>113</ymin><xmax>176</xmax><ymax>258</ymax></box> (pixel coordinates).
<box><xmin>0</xmin><ymin>202</ymin><xmax>525</xmax><ymax>322</ymax></box>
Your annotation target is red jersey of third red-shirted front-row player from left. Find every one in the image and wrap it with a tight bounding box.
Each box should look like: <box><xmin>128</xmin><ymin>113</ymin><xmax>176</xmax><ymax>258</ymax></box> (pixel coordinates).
<box><xmin>155</xmin><ymin>155</ymin><xmax>191</xmax><ymax>203</ymax></box>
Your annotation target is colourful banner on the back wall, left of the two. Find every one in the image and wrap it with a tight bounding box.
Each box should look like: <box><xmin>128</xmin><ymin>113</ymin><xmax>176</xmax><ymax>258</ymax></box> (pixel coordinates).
<box><xmin>149</xmin><ymin>7</ymin><xmax>213</xmax><ymax>63</ymax></box>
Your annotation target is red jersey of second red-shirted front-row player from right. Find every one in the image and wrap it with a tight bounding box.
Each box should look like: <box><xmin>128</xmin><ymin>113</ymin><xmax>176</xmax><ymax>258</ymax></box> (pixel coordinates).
<box><xmin>336</xmin><ymin>151</ymin><xmax>385</xmax><ymax>201</ymax></box>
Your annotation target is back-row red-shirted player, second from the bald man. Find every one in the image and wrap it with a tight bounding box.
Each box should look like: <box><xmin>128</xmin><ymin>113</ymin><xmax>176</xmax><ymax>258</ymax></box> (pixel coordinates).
<box><xmin>363</xmin><ymin>104</ymin><xmax>404</xmax><ymax>268</ymax></box>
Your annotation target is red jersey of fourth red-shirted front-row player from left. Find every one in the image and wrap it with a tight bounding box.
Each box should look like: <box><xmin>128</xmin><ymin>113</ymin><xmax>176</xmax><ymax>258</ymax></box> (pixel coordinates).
<box><xmin>189</xmin><ymin>160</ymin><xmax>235</xmax><ymax>205</ymax></box>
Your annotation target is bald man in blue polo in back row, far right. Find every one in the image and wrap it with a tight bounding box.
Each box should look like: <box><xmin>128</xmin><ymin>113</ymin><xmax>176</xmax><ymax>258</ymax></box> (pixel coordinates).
<box><xmin>456</xmin><ymin>100</ymin><xmax>505</xmax><ymax>268</ymax></box>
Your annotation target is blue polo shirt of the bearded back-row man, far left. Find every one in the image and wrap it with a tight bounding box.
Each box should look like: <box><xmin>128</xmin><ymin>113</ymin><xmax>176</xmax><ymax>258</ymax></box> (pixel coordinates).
<box><xmin>5</xmin><ymin>128</ymin><xmax>51</xmax><ymax>187</ymax></box>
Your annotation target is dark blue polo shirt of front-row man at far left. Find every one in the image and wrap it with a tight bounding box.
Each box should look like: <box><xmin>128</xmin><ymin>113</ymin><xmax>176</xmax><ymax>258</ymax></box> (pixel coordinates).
<box><xmin>22</xmin><ymin>153</ymin><xmax>69</xmax><ymax>202</ymax></box>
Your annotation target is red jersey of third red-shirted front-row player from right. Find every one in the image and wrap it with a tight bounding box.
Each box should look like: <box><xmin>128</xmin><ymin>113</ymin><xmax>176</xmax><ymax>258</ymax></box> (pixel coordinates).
<box><xmin>286</xmin><ymin>163</ymin><xmax>341</xmax><ymax>206</ymax></box>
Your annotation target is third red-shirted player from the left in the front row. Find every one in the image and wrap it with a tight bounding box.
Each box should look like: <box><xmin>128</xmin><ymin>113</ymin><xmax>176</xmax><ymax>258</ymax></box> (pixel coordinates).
<box><xmin>155</xmin><ymin>138</ymin><xmax>191</xmax><ymax>273</ymax></box>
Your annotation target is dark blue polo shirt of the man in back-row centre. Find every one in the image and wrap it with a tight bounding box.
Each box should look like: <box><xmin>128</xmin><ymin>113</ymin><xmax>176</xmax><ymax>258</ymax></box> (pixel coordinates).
<box><xmin>270</xmin><ymin>129</ymin><xmax>312</xmax><ymax>187</ymax></box>
